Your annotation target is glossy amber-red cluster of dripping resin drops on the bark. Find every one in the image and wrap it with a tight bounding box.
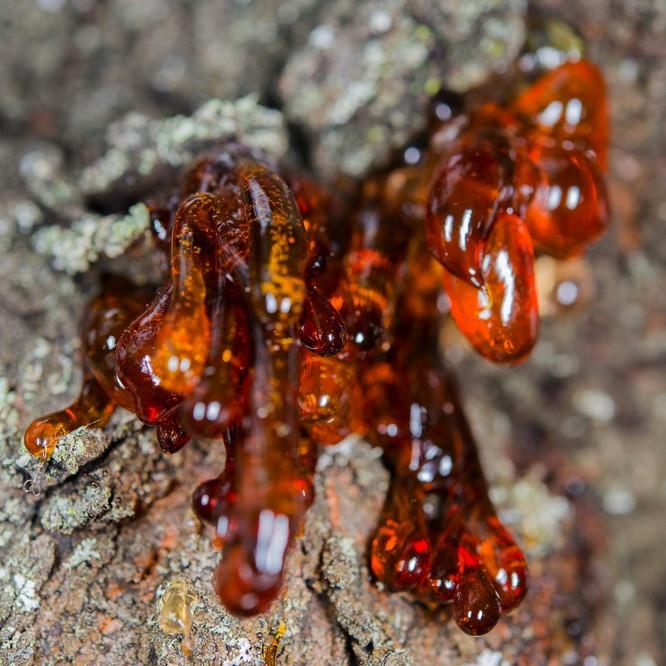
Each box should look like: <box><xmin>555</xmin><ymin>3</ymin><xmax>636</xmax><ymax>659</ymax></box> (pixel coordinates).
<box><xmin>25</xmin><ymin>61</ymin><xmax>608</xmax><ymax>634</ymax></box>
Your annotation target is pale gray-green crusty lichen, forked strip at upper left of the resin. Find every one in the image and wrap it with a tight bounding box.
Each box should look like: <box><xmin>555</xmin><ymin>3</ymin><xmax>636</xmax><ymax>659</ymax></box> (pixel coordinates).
<box><xmin>22</xmin><ymin>95</ymin><xmax>287</xmax><ymax>274</ymax></box>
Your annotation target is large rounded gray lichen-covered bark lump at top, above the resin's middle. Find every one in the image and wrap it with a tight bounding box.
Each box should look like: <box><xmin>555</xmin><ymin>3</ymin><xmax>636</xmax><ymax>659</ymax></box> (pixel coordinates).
<box><xmin>280</xmin><ymin>0</ymin><xmax>525</xmax><ymax>176</ymax></box>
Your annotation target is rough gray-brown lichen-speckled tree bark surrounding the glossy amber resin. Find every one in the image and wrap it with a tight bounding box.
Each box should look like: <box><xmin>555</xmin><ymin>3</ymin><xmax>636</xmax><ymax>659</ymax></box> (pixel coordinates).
<box><xmin>0</xmin><ymin>0</ymin><xmax>666</xmax><ymax>666</ymax></box>
